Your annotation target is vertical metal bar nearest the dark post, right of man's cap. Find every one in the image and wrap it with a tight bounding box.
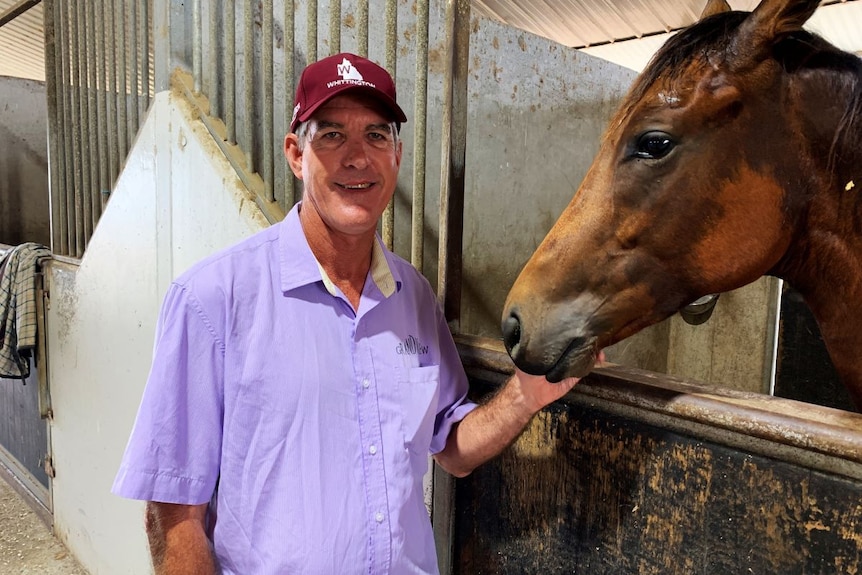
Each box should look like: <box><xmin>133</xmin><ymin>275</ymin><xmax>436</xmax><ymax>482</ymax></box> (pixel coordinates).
<box><xmin>410</xmin><ymin>0</ymin><xmax>429</xmax><ymax>272</ymax></box>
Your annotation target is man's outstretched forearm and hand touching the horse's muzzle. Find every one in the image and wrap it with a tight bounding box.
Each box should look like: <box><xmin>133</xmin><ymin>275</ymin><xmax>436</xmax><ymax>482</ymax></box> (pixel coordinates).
<box><xmin>434</xmin><ymin>368</ymin><xmax>579</xmax><ymax>477</ymax></box>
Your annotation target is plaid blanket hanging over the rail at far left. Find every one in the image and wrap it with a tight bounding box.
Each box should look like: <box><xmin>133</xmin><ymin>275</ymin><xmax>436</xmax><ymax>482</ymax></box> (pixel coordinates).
<box><xmin>0</xmin><ymin>243</ymin><xmax>51</xmax><ymax>379</ymax></box>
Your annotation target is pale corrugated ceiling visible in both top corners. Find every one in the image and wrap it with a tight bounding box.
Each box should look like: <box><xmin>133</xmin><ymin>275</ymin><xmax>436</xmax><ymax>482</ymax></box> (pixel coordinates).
<box><xmin>0</xmin><ymin>0</ymin><xmax>862</xmax><ymax>81</ymax></box>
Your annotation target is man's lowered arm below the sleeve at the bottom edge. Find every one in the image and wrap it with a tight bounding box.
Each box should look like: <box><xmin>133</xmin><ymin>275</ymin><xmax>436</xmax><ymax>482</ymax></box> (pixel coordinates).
<box><xmin>146</xmin><ymin>501</ymin><xmax>216</xmax><ymax>575</ymax></box>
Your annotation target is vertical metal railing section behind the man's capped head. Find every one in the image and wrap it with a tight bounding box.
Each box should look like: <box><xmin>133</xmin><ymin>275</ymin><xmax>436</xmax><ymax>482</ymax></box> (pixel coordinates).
<box><xmin>155</xmin><ymin>0</ymin><xmax>470</xmax><ymax>329</ymax></box>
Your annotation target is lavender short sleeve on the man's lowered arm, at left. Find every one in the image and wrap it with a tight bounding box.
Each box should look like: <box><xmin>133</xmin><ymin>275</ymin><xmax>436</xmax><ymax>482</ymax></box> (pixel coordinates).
<box><xmin>112</xmin><ymin>283</ymin><xmax>224</xmax><ymax>505</ymax></box>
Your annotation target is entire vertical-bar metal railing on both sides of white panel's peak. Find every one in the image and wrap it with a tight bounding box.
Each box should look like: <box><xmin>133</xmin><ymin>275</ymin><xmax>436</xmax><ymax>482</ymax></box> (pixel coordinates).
<box><xmin>44</xmin><ymin>0</ymin><xmax>470</xmax><ymax>322</ymax></box>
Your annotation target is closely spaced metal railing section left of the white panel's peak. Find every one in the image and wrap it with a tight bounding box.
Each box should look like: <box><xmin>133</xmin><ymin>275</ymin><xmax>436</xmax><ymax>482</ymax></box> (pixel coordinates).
<box><xmin>43</xmin><ymin>0</ymin><xmax>154</xmax><ymax>258</ymax></box>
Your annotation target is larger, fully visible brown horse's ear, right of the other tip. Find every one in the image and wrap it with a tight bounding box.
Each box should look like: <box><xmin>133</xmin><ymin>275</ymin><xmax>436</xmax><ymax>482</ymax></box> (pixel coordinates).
<box><xmin>732</xmin><ymin>0</ymin><xmax>820</xmax><ymax>65</ymax></box>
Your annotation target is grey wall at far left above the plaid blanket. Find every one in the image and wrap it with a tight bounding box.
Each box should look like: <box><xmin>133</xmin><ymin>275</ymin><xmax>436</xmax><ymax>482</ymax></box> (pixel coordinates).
<box><xmin>0</xmin><ymin>76</ymin><xmax>51</xmax><ymax>246</ymax></box>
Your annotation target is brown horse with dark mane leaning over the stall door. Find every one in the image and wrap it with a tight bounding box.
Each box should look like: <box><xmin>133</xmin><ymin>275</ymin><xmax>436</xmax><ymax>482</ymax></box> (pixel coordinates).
<box><xmin>503</xmin><ymin>0</ymin><xmax>862</xmax><ymax>407</ymax></box>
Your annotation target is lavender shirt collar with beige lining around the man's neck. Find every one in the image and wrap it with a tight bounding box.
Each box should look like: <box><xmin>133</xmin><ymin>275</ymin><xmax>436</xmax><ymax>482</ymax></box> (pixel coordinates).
<box><xmin>278</xmin><ymin>202</ymin><xmax>401</xmax><ymax>298</ymax></box>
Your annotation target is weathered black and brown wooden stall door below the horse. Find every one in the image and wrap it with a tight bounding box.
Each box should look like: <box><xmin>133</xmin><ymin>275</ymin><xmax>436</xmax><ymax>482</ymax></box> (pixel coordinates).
<box><xmin>452</xmin><ymin>338</ymin><xmax>862</xmax><ymax>575</ymax></box>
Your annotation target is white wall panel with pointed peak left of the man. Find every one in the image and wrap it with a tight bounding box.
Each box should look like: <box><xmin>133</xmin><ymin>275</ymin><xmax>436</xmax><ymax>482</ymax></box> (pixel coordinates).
<box><xmin>48</xmin><ymin>88</ymin><xmax>268</xmax><ymax>575</ymax></box>
